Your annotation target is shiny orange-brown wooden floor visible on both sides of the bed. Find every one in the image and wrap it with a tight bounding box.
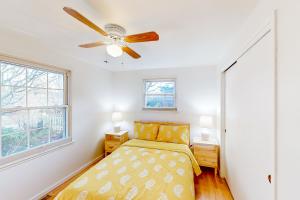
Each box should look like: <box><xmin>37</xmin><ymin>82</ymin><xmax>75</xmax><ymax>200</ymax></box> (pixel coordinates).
<box><xmin>42</xmin><ymin>165</ymin><xmax>233</xmax><ymax>200</ymax></box>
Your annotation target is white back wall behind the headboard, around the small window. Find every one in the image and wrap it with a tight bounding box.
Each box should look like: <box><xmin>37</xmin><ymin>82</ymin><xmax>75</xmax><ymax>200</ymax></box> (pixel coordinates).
<box><xmin>113</xmin><ymin>66</ymin><xmax>218</xmax><ymax>141</ymax></box>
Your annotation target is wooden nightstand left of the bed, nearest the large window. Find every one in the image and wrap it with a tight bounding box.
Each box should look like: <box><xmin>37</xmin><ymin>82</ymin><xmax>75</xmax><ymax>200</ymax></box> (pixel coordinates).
<box><xmin>105</xmin><ymin>131</ymin><xmax>128</xmax><ymax>156</ymax></box>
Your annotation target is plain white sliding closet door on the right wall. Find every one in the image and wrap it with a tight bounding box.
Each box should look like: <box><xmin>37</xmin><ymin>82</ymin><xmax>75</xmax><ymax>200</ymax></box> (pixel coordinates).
<box><xmin>225</xmin><ymin>33</ymin><xmax>275</xmax><ymax>200</ymax></box>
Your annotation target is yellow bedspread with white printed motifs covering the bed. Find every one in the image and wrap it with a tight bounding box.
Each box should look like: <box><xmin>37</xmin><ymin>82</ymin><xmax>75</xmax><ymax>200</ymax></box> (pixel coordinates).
<box><xmin>55</xmin><ymin>139</ymin><xmax>201</xmax><ymax>200</ymax></box>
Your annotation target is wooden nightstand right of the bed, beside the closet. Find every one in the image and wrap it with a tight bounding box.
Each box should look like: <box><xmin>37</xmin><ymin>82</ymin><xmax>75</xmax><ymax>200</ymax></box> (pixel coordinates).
<box><xmin>193</xmin><ymin>138</ymin><xmax>219</xmax><ymax>175</ymax></box>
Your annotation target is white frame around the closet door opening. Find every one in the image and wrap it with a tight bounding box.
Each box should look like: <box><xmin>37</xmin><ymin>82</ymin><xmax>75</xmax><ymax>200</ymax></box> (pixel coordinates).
<box><xmin>218</xmin><ymin>10</ymin><xmax>278</xmax><ymax>200</ymax></box>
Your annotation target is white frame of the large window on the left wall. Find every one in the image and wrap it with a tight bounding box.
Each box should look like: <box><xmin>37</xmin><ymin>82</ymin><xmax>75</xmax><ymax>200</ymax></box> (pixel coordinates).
<box><xmin>0</xmin><ymin>54</ymin><xmax>73</xmax><ymax>170</ymax></box>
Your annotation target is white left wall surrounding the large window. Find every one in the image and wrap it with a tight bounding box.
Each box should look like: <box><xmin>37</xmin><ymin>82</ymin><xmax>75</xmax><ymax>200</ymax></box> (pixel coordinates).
<box><xmin>0</xmin><ymin>29</ymin><xmax>112</xmax><ymax>200</ymax></box>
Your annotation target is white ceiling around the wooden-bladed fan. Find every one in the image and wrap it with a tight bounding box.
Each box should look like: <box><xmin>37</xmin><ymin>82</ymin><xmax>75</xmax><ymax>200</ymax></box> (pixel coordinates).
<box><xmin>0</xmin><ymin>0</ymin><xmax>258</xmax><ymax>71</ymax></box>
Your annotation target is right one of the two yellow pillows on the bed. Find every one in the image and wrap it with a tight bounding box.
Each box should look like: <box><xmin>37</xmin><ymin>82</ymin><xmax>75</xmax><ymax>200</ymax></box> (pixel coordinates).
<box><xmin>157</xmin><ymin>125</ymin><xmax>190</xmax><ymax>145</ymax></box>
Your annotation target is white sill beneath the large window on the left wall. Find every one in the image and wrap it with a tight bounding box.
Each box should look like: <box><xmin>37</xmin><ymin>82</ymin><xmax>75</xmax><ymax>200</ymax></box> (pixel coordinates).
<box><xmin>0</xmin><ymin>138</ymin><xmax>75</xmax><ymax>171</ymax></box>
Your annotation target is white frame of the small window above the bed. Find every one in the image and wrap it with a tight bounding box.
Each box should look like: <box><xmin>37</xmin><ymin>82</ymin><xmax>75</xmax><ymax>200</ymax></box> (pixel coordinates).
<box><xmin>143</xmin><ymin>78</ymin><xmax>177</xmax><ymax>111</ymax></box>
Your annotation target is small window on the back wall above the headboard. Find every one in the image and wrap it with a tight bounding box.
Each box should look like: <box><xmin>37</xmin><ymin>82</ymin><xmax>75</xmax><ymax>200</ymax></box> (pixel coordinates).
<box><xmin>144</xmin><ymin>79</ymin><xmax>176</xmax><ymax>110</ymax></box>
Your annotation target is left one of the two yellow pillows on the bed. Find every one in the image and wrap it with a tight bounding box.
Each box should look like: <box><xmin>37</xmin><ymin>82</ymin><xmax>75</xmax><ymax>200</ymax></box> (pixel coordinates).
<box><xmin>134</xmin><ymin>123</ymin><xmax>159</xmax><ymax>141</ymax></box>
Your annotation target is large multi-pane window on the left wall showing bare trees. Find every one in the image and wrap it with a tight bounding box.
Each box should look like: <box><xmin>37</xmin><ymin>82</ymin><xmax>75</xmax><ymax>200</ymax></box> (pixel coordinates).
<box><xmin>0</xmin><ymin>56</ymin><xmax>69</xmax><ymax>164</ymax></box>
